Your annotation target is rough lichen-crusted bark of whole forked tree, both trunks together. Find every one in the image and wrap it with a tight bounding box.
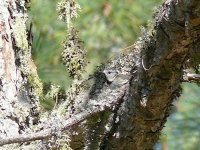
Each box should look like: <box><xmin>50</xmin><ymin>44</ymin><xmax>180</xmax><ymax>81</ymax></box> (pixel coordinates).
<box><xmin>0</xmin><ymin>0</ymin><xmax>200</xmax><ymax>150</ymax></box>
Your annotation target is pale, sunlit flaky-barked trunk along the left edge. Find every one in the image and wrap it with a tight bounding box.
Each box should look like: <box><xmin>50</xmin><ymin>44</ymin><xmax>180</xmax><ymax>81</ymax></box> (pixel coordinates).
<box><xmin>0</xmin><ymin>0</ymin><xmax>40</xmax><ymax>149</ymax></box>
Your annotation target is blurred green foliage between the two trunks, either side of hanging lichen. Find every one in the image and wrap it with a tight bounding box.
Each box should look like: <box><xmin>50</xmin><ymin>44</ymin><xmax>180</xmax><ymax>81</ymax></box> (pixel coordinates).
<box><xmin>30</xmin><ymin>0</ymin><xmax>160</xmax><ymax>87</ymax></box>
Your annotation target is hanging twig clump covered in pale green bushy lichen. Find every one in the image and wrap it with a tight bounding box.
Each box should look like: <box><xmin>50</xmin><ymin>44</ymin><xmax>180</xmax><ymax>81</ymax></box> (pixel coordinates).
<box><xmin>57</xmin><ymin>0</ymin><xmax>86</xmax><ymax>79</ymax></box>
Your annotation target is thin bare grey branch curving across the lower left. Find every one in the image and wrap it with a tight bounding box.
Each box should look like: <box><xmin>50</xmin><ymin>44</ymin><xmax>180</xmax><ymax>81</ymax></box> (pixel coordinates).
<box><xmin>0</xmin><ymin>85</ymin><xmax>127</xmax><ymax>146</ymax></box>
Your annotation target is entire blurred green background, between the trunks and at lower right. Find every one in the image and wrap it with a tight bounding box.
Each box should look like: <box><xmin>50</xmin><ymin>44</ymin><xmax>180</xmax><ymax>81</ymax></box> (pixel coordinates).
<box><xmin>29</xmin><ymin>0</ymin><xmax>200</xmax><ymax>150</ymax></box>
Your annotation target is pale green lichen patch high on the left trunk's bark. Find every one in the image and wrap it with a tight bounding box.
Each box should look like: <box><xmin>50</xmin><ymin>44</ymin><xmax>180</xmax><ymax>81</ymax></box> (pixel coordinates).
<box><xmin>13</xmin><ymin>16</ymin><xmax>28</xmax><ymax>51</ymax></box>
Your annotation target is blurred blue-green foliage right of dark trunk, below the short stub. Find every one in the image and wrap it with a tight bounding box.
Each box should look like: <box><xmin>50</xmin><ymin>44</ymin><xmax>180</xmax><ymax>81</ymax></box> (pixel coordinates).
<box><xmin>161</xmin><ymin>84</ymin><xmax>200</xmax><ymax>150</ymax></box>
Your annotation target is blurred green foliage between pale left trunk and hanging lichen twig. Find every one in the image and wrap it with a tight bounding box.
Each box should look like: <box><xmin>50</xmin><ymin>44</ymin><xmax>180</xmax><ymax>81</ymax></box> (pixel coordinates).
<box><xmin>29</xmin><ymin>0</ymin><xmax>70</xmax><ymax>87</ymax></box>
